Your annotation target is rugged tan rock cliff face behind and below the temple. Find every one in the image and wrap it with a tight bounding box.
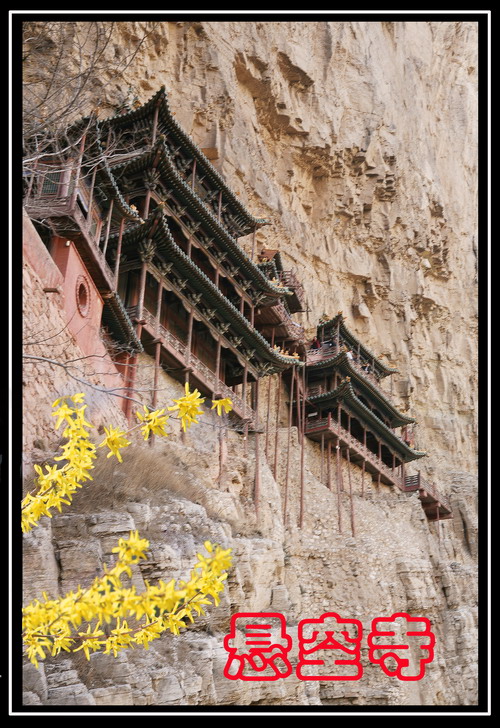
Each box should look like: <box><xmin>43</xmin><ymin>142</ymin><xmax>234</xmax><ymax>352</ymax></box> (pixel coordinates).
<box><xmin>21</xmin><ymin>22</ymin><xmax>477</xmax><ymax>705</ymax></box>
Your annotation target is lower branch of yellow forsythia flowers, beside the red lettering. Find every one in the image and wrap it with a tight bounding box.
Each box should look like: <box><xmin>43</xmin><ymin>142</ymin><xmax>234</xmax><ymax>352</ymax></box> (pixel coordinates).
<box><xmin>23</xmin><ymin>531</ymin><xmax>231</xmax><ymax>668</ymax></box>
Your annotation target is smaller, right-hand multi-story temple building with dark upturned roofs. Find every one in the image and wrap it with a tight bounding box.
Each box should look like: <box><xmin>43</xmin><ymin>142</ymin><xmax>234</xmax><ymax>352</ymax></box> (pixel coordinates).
<box><xmin>304</xmin><ymin>312</ymin><xmax>451</xmax><ymax>520</ymax></box>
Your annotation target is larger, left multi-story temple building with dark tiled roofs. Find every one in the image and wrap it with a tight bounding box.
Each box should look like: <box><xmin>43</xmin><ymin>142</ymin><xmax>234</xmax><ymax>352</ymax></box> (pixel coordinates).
<box><xmin>26</xmin><ymin>87</ymin><xmax>303</xmax><ymax>427</ymax></box>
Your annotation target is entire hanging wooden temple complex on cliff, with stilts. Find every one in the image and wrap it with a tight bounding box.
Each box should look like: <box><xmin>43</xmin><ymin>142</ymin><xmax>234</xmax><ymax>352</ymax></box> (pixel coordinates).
<box><xmin>24</xmin><ymin>87</ymin><xmax>451</xmax><ymax>532</ymax></box>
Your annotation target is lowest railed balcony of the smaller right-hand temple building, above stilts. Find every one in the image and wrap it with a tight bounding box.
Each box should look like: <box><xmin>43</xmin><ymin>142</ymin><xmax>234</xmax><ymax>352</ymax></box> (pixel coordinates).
<box><xmin>304</xmin><ymin>414</ymin><xmax>404</xmax><ymax>490</ymax></box>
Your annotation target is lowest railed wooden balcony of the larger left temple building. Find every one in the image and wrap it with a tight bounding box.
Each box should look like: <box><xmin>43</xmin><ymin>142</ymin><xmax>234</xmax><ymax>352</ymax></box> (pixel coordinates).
<box><xmin>127</xmin><ymin>306</ymin><xmax>261</xmax><ymax>431</ymax></box>
